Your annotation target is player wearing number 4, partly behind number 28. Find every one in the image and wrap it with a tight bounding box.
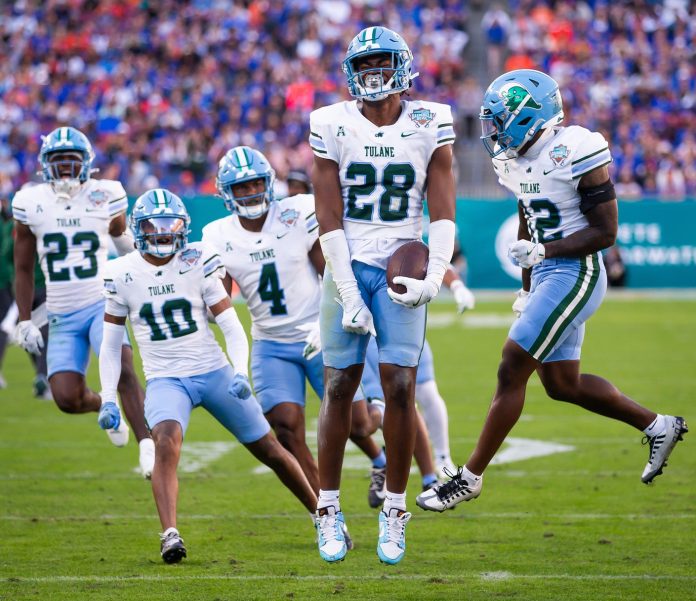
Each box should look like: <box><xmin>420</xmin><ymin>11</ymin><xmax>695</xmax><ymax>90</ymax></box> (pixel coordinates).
<box><xmin>203</xmin><ymin>146</ymin><xmax>386</xmax><ymax>516</ymax></box>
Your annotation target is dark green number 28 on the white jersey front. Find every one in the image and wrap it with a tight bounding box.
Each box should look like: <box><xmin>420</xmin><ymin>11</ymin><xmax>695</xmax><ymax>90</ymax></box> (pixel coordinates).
<box><xmin>346</xmin><ymin>163</ymin><xmax>416</xmax><ymax>221</ymax></box>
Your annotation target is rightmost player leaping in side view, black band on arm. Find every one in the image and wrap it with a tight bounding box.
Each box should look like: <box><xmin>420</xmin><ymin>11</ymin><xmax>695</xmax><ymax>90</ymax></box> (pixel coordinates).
<box><xmin>417</xmin><ymin>69</ymin><xmax>687</xmax><ymax>511</ymax></box>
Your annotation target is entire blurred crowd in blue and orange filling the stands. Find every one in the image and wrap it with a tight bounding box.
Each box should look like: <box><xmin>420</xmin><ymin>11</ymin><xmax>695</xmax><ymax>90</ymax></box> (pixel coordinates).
<box><xmin>0</xmin><ymin>0</ymin><xmax>696</xmax><ymax>198</ymax></box>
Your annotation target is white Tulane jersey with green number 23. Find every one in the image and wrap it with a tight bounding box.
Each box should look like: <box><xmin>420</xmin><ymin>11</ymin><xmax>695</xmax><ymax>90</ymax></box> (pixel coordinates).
<box><xmin>12</xmin><ymin>179</ymin><xmax>128</xmax><ymax>314</ymax></box>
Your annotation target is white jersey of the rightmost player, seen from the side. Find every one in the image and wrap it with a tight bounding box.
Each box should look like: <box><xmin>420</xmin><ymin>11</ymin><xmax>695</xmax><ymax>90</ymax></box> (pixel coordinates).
<box><xmin>493</xmin><ymin>125</ymin><xmax>611</xmax><ymax>242</ymax></box>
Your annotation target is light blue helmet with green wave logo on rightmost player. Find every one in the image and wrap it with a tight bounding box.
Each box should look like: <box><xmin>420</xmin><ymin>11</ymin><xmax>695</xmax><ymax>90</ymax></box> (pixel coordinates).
<box><xmin>479</xmin><ymin>69</ymin><xmax>563</xmax><ymax>158</ymax></box>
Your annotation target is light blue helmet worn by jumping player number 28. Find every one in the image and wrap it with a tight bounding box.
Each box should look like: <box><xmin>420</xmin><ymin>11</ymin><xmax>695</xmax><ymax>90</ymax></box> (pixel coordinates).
<box><xmin>343</xmin><ymin>27</ymin><xmax>418</xmax><ymax>101</ymax></box>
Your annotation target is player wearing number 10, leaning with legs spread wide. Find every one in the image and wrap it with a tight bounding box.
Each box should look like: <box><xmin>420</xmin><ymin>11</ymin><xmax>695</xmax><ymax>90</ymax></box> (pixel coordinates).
<box><xmin>99</xmin><ymin>189</ymin><xmax>316</xmax><ymax>563</ymax></box>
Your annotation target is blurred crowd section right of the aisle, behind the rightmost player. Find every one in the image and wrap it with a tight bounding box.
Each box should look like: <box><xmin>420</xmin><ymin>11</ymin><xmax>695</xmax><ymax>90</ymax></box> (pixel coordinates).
<box><xmin>482</xmin><ymin>0</ymin><xmax>696</xmax><ymax>199</ymax></box>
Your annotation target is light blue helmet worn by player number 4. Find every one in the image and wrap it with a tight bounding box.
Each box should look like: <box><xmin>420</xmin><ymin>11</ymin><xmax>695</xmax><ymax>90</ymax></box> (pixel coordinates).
<box><xmin>215</xmin><ymin>146</ymin><xmax>275</xmax><ymax>219</ymax></box>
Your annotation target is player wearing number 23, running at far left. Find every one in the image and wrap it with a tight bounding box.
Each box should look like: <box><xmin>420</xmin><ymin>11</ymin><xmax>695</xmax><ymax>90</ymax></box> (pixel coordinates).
<box><xmin>12</xmin><ymin>127</ymin><xmax>154</xmax><ymax>477</ymax></box>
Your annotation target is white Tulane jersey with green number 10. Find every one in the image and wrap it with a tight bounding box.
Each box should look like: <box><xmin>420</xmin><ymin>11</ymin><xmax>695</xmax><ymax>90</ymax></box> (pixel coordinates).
<box><xmin>103</xmin><ymin>242</ymin><xmax>228</xmax><ymax>380</ymax></box>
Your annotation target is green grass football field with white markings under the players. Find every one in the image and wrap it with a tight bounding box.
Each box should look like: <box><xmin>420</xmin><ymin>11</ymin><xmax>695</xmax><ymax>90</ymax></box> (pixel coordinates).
<box><xmin>0</xmin><ymin>299</ymin><xmax>696</xmax><ymax>601</ymax></box>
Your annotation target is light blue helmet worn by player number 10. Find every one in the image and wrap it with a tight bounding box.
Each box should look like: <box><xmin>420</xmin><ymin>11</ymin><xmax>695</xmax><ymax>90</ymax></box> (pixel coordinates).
<box><xmin>129</xmin><ymin>188</ymin><xmax>191</xmax><ymax>257</ymax></box>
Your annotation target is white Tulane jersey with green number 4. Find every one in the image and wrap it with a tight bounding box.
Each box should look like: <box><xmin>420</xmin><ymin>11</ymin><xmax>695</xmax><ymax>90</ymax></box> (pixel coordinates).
<box><xmin>203</xmin><ymin>194</ymin><xmax>321</xmax><ymax>342</ymax></box>
